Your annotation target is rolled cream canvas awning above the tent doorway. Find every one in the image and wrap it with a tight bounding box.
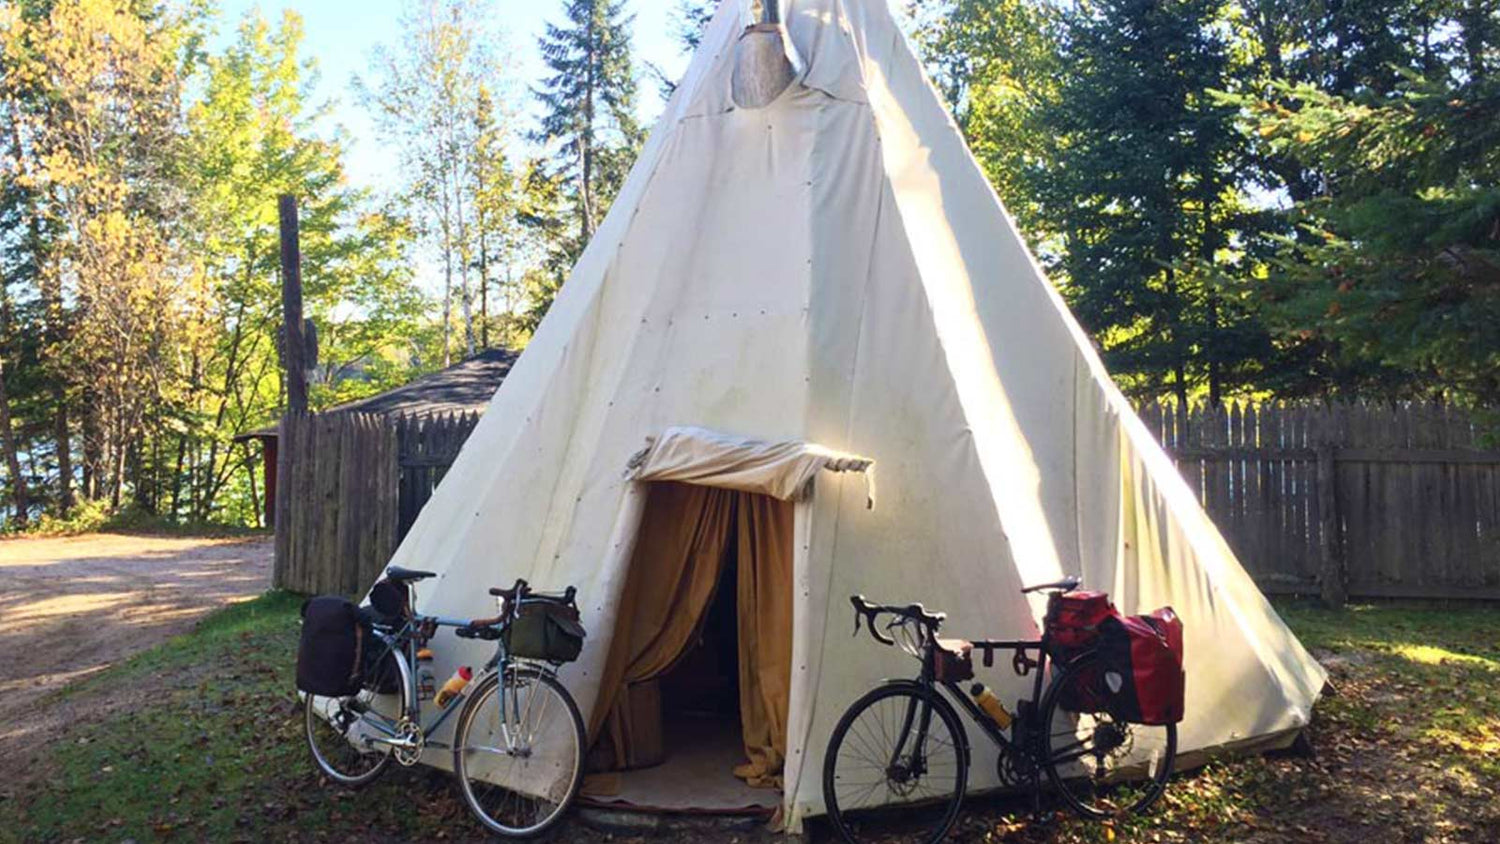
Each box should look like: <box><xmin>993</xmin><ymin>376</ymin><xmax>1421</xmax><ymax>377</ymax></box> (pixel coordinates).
<box><xmin>626</xmin><ymin>426</ymin><xmax>875</xmax><ymax>508</ymax></box>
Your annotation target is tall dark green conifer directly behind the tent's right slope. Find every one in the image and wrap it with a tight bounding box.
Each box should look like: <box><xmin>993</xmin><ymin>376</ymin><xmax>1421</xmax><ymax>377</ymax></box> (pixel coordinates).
<box><xmin>1032</xmin><ymin>0</ymin><xmax>1269</xmax><ymax>403</ymax></box>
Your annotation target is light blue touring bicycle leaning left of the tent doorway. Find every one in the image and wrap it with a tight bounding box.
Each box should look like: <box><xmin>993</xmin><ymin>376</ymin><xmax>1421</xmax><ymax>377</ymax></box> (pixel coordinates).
<box><xmin>303</xmin><ymin>565</ymin><xmax>587</xmax><ymax>838</ymax></box>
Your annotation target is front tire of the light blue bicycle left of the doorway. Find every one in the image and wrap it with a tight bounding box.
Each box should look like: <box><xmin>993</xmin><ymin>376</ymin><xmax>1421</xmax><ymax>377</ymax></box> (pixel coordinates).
<box><xmin>453</xmin><ymin>666</ymin><xmax>587</xmax><ymax>838</ymax></box>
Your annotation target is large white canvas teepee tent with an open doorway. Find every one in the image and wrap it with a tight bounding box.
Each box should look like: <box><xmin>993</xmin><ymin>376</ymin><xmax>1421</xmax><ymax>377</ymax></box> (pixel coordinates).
<box><xmin>393</xmin><ymin>0</ymin><xmax>1323</xmax><ymax>826</ymax></box>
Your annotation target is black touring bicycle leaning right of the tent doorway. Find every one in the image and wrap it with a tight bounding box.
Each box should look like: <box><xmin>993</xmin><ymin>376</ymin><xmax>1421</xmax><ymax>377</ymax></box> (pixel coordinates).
<box><xmin>824</xmin><ymin>577</ymin><xmax>1178</xmax><ymax>843</ymax></box>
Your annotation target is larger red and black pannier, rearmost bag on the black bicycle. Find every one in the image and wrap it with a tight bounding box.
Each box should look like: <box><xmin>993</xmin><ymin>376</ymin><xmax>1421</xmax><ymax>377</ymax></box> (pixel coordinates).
<box><xmin>1098</xmin><ymin>607</ymin><xmax>1187</xmax><ymax>724</ymax></box>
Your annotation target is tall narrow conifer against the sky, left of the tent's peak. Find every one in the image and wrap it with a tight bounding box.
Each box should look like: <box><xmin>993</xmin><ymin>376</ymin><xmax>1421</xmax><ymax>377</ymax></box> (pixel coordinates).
<box><xmin>534</xmin><ymin>0</ymin><xmax>641</xmax><ymax>247</ymax></box>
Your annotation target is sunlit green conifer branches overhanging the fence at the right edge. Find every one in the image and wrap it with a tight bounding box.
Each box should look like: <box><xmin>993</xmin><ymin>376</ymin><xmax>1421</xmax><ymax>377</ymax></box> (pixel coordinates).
<box><xmin>1236</xmin><ymin>72</ymin><xmax>1500</xmax><ymax>403</ymax></box>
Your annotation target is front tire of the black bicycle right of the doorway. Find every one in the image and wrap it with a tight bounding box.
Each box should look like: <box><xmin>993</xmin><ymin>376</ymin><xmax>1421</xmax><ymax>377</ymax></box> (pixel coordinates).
<box><xmin>824</xmin><ymin>682</ymin><xmax>969</xmax><ymax>844</ymax></box>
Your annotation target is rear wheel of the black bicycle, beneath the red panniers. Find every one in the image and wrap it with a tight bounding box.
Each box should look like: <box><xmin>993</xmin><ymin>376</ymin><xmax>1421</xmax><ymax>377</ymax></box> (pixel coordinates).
<box><xmin>1043</xmin><ymin>657</ymin><xmax>1178</xmax><ymax>819</ymax></box>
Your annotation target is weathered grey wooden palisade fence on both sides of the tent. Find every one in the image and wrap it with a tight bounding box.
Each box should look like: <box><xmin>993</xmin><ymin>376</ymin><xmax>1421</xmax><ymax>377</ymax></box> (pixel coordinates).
<box><xmin>275</xmin><ymin>403</ymin><xmax>1500</xmax><ymax>604</ymax></box>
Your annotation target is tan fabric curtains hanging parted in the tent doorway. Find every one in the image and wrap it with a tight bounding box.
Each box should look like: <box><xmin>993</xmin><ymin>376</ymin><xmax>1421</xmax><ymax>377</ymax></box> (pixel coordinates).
<box><xmin>590</xmin><ymin>483</ymin><xmax>794</xmax><ymax>787</ymax></box>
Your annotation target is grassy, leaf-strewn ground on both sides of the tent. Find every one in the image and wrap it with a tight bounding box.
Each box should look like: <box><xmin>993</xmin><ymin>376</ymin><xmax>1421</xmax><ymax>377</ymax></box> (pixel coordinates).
<box><xmin>0</xmin><ymin>592</ymin><xmax>1500</xmax><ymax>843</ymax></box>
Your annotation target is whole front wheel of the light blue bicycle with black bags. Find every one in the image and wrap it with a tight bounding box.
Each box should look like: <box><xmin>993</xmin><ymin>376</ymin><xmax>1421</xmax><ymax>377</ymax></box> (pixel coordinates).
<box><xmin>453</xmin><ymin>667</ymin><xmax>584</xmax><ymax>838</ymax></box>
